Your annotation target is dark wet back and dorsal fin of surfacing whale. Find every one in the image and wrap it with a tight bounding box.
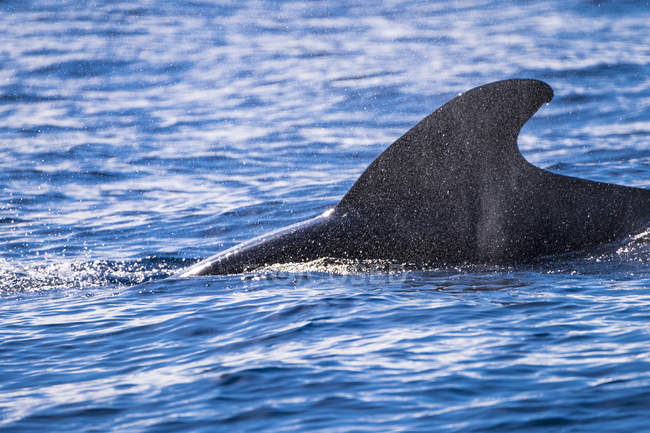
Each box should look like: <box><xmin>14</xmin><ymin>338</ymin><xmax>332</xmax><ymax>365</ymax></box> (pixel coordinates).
<box><xmin>181</xmin><ymin>79</ymin><xmax>650</xmax><ymax>276</ymax></box>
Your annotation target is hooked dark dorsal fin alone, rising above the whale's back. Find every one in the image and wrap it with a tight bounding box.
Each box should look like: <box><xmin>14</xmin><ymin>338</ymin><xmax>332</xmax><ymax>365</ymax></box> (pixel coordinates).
<box><xmin>337</xmin><ymin>79</ymin><xmax>553</xmax><ymax>213</ymax></box>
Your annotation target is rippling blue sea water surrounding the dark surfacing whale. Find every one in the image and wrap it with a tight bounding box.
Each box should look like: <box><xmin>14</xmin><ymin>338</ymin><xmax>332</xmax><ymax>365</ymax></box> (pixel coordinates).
<box><xmin>0</xmin><ymin>0</ymin><xmax>650</xmax><ymax>432</ymax></box>
